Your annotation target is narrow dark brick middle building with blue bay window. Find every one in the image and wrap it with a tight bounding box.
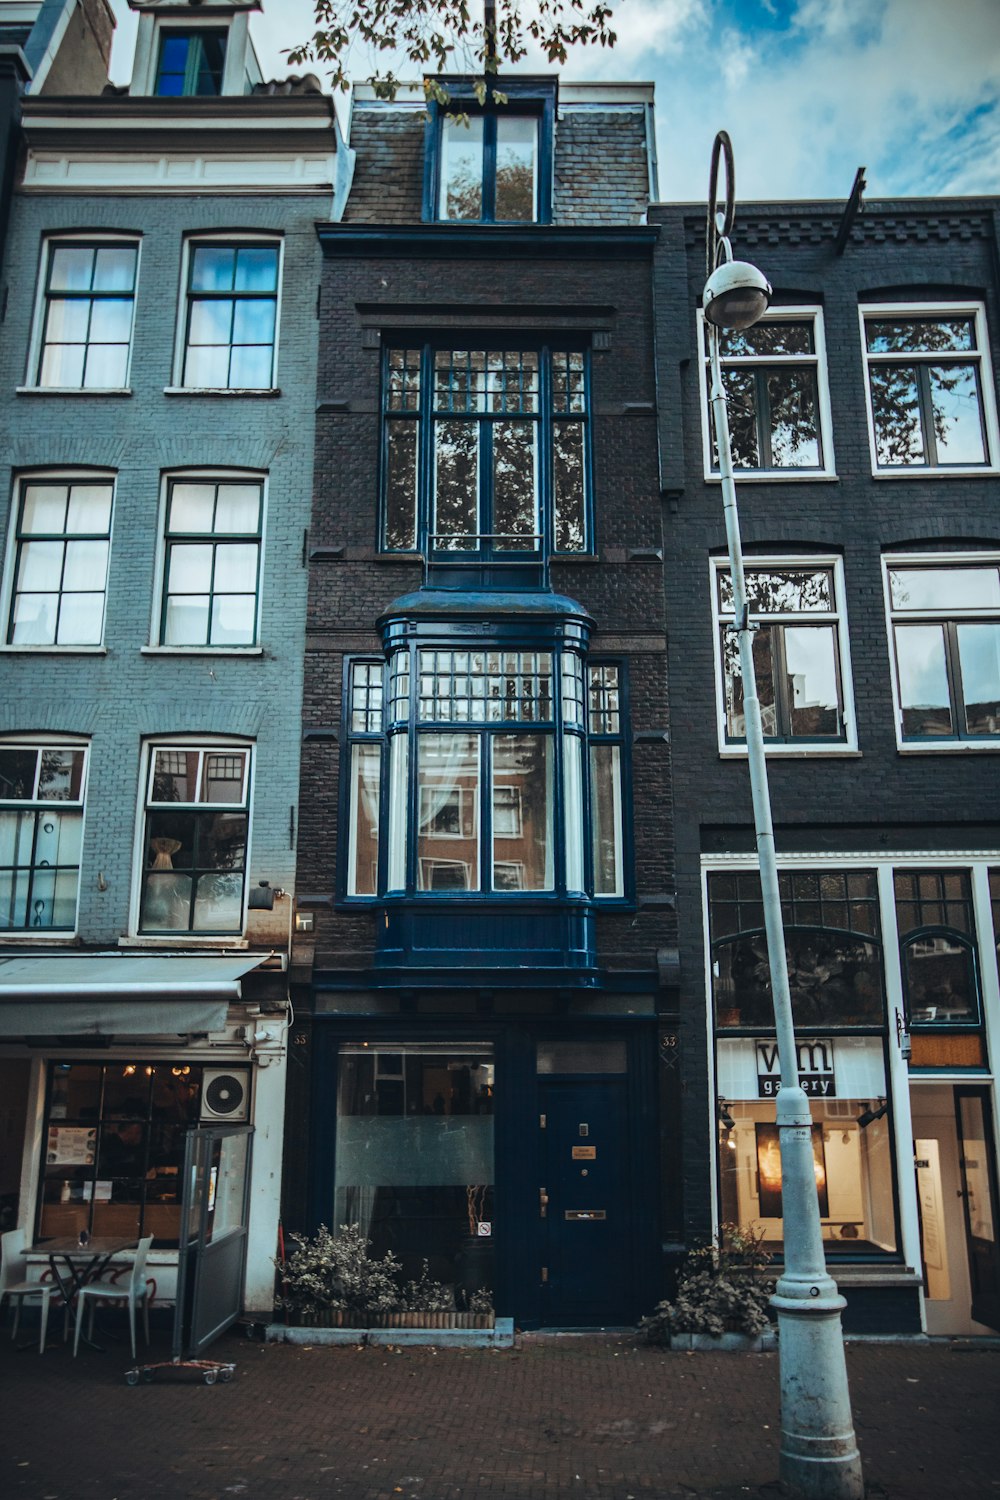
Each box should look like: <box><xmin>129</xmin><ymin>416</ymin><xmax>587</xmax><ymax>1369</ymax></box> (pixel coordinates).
<box><xmin>285</xmin><ymin>77</ymin><xmax>678</xmax><ymax>1326</ymax></box>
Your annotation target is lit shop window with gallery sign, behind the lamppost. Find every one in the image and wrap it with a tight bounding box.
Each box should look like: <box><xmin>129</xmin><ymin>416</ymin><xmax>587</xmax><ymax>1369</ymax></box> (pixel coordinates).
<box><xmin>718</xmin><ymin>1037</ymin><xmax>898</xmax><ymax>1257</ymax></box>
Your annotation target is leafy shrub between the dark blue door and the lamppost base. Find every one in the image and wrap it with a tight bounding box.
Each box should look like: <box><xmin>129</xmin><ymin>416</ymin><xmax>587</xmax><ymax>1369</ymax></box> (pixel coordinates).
<box><xmin>639</xmin><ymin>1224</ymin><xmax>774</xmax><ymax>1344</ymax></box>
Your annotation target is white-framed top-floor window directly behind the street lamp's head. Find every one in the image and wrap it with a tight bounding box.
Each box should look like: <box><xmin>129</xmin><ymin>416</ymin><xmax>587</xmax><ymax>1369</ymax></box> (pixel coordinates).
<box><xmin>703</xmin><ymin>308</ymin><xmax>834</xmax><ymax>474</ymax></box>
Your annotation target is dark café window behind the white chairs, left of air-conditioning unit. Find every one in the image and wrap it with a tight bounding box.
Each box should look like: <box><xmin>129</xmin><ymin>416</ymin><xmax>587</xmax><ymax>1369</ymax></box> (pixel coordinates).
<box><xmin>37</xmin><ymin>1061</ymin><xmax>209</xmax><ymax>1250</ymax></box>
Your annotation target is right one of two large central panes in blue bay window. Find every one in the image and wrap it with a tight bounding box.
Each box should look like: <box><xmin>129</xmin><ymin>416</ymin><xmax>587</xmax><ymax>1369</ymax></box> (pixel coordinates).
<box><xmin>493</xmin><ymin>735</ymin><xmax>555</xmax><ymax>891</ymax></box>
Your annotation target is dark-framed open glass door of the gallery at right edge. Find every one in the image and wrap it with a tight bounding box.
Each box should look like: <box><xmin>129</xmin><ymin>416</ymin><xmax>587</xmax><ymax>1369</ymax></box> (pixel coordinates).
<box><xmin>955</xmin><ymin>1088</ymin><xmax>1000</xmax><ymax>1329</ymax></box>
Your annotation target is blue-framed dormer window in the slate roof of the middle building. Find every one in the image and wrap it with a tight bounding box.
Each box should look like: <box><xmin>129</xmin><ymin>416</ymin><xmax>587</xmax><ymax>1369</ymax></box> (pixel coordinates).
<box><xmin>423</xmin><ymin>80</ymin><xmax>556</xmax><ymax>225</ymax></box>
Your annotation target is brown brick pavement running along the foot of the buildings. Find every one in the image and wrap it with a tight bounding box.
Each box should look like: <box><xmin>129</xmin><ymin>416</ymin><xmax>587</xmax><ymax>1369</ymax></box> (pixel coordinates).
<box><xmin>0</xmin><ymin>1323</ymin><xmax>1000</xmax><ymax>1500</ymax></box>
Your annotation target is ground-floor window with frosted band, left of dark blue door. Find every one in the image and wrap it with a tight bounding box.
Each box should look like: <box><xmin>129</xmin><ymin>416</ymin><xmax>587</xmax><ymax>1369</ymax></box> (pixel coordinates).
<box><xmin>333</xmin><ymin>1043</ymin><xmax>495</xmax><ymax>1305</ymax></box>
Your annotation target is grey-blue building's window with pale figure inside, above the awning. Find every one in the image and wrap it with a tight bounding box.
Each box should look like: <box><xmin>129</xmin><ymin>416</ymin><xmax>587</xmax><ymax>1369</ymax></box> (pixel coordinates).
<box><xmin>139</xmin><ymin>746</ymin><xmax>250</xmax><ymax>935</ymax></box>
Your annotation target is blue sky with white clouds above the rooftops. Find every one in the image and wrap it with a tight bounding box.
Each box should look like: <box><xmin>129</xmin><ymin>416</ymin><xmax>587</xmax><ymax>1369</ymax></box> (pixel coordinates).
<box><xmin>111</xmin><ymin>0</ymin><xmax>1000</xmax><ymax>201</ymax></box>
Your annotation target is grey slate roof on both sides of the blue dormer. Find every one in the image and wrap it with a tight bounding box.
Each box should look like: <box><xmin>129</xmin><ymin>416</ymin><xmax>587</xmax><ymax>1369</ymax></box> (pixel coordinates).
<box><xmin>343</xmin><ymin>90</ymin><xmax>649</xmax><ymax>225</ymax></box>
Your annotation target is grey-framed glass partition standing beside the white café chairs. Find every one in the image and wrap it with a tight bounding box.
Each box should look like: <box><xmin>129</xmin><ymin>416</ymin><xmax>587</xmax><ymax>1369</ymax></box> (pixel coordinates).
<box><xmin>174</xmin><ymin>1125</ymin><xmax>253</xmax><ymax>1359</ymax></box>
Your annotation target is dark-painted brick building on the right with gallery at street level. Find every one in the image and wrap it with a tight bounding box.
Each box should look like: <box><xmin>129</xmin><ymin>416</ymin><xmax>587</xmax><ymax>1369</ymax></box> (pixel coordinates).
<box><xmin>651</xmin><ymin>200</ymin><xmax>1000</xmax><ymax>1334</ymax></box>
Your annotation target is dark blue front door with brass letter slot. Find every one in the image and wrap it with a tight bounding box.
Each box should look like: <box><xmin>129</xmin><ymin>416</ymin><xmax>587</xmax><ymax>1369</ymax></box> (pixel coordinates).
<box><xmin>538</xmin><ymin>1077</ymin><xmax>634</xmax><ymax>1328</ymax></box>
